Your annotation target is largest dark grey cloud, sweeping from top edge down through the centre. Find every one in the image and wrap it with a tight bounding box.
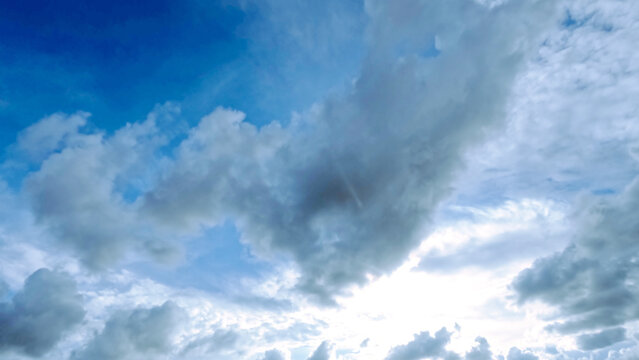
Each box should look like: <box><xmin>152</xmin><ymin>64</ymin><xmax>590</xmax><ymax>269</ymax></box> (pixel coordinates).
<box><xmin>143</xmin><ymin>0</ymin><xmax>552</xmax><ymax>304</ymax></box>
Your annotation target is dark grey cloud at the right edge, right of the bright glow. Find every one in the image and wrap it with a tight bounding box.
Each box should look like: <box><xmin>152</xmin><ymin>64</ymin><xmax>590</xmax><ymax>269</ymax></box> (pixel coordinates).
<box><xmin>512</xmin><ymin>180</ymin><xmax>639</xmax><ymax>340</ymax></box>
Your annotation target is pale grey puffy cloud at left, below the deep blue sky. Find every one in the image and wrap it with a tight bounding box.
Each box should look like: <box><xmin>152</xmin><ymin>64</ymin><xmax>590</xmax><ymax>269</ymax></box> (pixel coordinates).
<box><xmin>23</xmin><ymin>105</ymin><xmax>181</xmax><ymax>269</ymax></box>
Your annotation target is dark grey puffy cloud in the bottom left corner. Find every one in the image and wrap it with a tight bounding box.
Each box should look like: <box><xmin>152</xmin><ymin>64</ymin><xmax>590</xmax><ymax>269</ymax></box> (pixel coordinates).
<box><xmin>0</xmin><ymin>269</ymin><xmax>85</xmax><ymax>356</ymax></box>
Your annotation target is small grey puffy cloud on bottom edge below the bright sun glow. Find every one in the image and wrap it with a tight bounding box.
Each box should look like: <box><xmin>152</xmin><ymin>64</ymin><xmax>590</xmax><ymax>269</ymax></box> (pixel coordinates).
<box><xmin>386</xmin><ymin>328</ymin><xmax>460</xmax><ymax>360</ymax></box>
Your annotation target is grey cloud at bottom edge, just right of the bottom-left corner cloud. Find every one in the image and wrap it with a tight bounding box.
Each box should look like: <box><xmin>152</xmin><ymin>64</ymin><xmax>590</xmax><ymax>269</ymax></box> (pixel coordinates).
<box><xmin>72</xmin><ymin>301</ymin><xmax>184</xmax><ymax>360</ymax></box>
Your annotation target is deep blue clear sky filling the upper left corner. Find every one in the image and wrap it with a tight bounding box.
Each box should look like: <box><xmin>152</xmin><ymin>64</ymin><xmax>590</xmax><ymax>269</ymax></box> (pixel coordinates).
<box><xmin>0</xmin><ymin>0</ymin><xmax>365</xmax><ymax>148</ymax></box>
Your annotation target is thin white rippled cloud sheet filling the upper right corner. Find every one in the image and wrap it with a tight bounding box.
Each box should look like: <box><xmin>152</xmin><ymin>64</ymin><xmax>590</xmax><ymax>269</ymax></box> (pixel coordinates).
<box><xmin>455</xmin><ymin>0</ymin><xmax>639</xmax><ymax>204</ymax></box>
